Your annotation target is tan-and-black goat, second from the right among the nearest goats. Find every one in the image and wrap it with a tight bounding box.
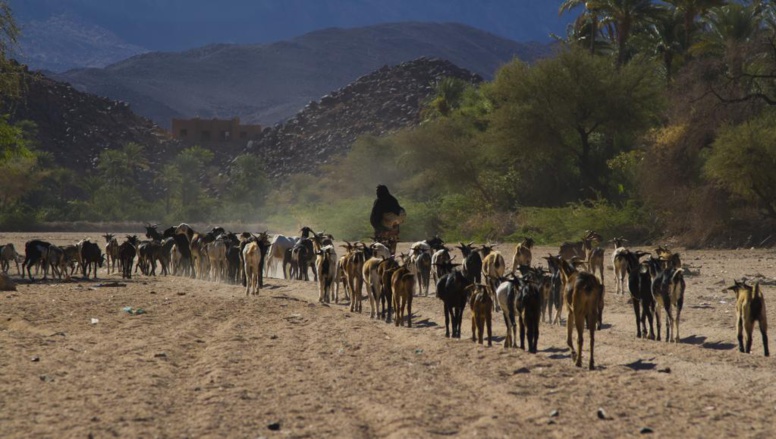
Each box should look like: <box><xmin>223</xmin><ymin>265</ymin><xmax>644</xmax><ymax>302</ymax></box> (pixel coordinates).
<box><xmin>648</xmin><ymin>258</ymin><xmax>685</xmax><ymax>343</ymax></box>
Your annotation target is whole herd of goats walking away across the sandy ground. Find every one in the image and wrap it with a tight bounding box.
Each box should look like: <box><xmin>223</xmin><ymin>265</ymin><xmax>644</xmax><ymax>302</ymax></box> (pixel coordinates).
<box><xmin>0</xmin><ymin>224</ymin><xmax>769</xmax><ymax>369</ymax></box>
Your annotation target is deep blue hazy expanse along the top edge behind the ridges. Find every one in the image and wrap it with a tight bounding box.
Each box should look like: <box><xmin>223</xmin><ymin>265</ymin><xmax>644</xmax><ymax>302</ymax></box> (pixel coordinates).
<box><xmin>8</xmin><ymin>0</ymin><xmax>573</xmax><ymax>59</ymax></box>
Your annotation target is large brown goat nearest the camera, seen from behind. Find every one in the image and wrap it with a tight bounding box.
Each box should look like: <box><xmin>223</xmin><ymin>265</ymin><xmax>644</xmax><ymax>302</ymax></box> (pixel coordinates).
<box><xmin>560</xmin><ymin>260</ymin><xmax>604</xmax><ymax>370</ymax></box>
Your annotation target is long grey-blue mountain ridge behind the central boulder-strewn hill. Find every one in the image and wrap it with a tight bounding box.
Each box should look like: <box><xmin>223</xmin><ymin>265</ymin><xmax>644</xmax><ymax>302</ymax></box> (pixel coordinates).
<box><xmin>56</xmin><ymin>23</ymin><xmax>550</xmax><ymax>127</ymax></box>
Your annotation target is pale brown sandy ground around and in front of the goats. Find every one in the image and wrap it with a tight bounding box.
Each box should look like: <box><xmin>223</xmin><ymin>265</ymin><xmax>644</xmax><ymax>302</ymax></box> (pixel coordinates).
<box><xmin>0</xmin><ymin>233</ymin><xmax>776</xmax><ymax>438</ymax></box>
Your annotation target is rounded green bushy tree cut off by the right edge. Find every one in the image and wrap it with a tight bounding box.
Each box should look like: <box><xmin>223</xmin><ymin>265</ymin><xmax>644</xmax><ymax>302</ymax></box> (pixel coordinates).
<box><xmin>704</xmin><ymin>111</ymin><xmax>776</xmax><ymax>219</ymax></box>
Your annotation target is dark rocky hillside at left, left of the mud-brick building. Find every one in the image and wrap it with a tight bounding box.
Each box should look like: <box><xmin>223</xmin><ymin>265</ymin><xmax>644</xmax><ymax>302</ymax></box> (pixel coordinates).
<box><xmin>0</xmin><ymin>62</ymin><xmax>180</xmax><ymax>172</ymax></box>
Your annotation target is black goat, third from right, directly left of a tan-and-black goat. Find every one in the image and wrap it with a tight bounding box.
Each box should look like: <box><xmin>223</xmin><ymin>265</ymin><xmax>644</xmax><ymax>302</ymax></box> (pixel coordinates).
<box><xmin>620</xmin><ymin>250</ymin><xmax>655</xmax><ymax>340</ymax></box>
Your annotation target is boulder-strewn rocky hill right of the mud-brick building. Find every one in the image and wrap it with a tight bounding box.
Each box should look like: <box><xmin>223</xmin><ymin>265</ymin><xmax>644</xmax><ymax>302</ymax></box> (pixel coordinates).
<box><xmin>236</xmin><ymin>58</ymin><xmax>482</xmax><ymax>180</ymax></box>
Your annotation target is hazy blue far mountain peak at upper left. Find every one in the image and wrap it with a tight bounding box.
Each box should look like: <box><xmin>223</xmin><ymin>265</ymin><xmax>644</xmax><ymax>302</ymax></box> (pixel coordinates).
<box><xmin>15</xmin><ymin>14</ymin><xmax>148</xmax><ymax>72</ymax></box>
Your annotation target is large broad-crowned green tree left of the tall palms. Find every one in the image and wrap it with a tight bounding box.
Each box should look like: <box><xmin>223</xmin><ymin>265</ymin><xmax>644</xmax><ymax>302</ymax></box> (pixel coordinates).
<box><xmin>489</xmin><ymin>49</ymin><xmax>662</xmax><ymax>201</ymax></box>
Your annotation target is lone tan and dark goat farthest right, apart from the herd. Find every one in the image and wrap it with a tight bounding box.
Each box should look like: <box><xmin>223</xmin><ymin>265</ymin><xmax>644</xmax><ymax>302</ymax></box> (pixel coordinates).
<box><xmin>728</xmin><ymin>280</ymin><xmax>770</xmax><ymax>357</ymax></box>
